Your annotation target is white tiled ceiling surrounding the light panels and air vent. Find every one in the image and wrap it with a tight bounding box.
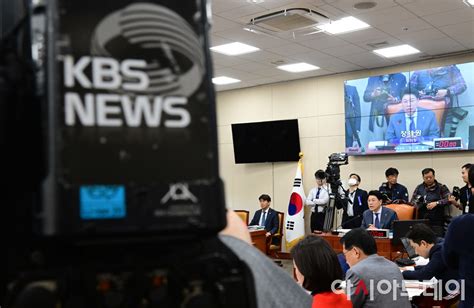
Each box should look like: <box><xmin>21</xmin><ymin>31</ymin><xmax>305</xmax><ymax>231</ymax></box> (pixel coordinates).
<box><xmin>211</xmin><ymin>0</ymin><xmax>474</xmax><ymax>91</ymax></box>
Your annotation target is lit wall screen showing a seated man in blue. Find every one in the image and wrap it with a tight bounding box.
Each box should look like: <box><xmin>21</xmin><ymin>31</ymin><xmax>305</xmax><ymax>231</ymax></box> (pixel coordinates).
<box><xmin>344</xmin><ymin>62</ymin><xmax>474</xmax><ymax>155</ymax></box>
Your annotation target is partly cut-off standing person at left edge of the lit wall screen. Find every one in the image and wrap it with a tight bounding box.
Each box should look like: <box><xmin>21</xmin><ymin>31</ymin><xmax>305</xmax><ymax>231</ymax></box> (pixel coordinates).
<box><xmin>344</xmin><ymin>81</ymin><xmax>362</xmax><ymax>148</ymax></box>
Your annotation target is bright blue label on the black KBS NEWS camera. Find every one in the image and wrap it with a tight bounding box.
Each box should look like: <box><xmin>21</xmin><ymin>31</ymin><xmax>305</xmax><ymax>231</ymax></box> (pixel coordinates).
<box><xmin>79</xmin><ymin>185</ymin><xmax>126</xmax><ymax>219</ymax></box>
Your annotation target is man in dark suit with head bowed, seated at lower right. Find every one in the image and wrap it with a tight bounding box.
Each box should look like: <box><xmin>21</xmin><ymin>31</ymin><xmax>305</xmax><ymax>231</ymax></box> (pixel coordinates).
<box><xmin>403</xmin><ymin>224</ymin><xmax>459</xmax><ymax>296</ymax></box>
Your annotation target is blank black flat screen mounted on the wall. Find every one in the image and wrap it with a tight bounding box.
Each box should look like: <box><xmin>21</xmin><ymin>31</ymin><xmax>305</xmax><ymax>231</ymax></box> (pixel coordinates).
<box><xmin>232</xmin><ymin>120</ymin><xmax>300</xmax><ymax>164</ymax></box>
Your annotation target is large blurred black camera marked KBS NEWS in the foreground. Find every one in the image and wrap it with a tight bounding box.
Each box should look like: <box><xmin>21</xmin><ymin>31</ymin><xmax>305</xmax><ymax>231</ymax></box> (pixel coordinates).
<box><xmin>0</xmin><ymin>0</ymin><xmax>255</xmax><ymax>308</ymax></box>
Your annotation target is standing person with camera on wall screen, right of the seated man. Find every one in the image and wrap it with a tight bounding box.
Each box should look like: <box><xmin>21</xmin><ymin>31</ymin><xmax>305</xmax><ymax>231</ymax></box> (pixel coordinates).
<box><xmin>409</xmin><ymin>65</ymin><xmax>467</xmax><ymax>137</ymax></box>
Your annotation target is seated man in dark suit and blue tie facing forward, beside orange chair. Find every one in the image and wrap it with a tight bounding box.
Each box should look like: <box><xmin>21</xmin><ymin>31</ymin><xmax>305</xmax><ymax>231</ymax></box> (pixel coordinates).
<box><xmin>361</xmin><ymin>190</ymin><xmax>398</xmax><ymax>229</ymax></box>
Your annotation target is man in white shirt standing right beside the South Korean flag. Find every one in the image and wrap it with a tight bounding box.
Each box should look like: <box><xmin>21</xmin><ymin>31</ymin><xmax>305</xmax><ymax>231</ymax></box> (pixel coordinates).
<box><xmin>306</xmin><ymin>169</ymin><xmax>329</xmax><ymax>232</ymax></box>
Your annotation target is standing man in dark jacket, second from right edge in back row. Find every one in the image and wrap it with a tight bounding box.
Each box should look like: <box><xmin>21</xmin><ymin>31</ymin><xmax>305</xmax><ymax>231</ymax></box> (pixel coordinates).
<box><xmin>411</xmin><ymin>168</ymin><xmax>451</xmax><ymax>237</ymax></box>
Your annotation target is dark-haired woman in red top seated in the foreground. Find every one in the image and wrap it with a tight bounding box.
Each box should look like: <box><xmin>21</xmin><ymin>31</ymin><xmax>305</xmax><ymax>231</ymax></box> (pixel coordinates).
<box><xmin>291</xmin><ymin>235</ymin><xmax>352</xmax><ymax>308</ymax></box>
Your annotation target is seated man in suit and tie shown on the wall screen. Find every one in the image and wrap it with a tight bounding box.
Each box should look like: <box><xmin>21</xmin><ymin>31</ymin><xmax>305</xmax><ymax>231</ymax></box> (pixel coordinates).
<box><xmin>385</xmin><ymin>89</ymin><xmax>439</xmax><ymax>144</ymax></box>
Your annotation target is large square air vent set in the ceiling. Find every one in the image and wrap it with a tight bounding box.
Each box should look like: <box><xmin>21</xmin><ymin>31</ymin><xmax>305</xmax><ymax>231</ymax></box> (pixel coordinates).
<box><xmin>247</xmin><ymin>8</ymin><xmax>330</xmax><ymax>33</ymax></box>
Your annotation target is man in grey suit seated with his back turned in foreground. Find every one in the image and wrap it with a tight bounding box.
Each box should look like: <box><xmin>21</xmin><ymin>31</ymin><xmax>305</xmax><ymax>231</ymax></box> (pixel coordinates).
<box><xmin>340</xmin><ymin>228</ymin><xmax>411</xmax><ymax>308</ymax></box>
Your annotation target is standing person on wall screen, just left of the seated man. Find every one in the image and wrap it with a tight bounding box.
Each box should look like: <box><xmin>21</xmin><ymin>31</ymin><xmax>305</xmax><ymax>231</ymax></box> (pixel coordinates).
<box><xmin>364</xmin><ymin>73</ymin><xmax>407</xmax><ymax>141</ymax></box>
